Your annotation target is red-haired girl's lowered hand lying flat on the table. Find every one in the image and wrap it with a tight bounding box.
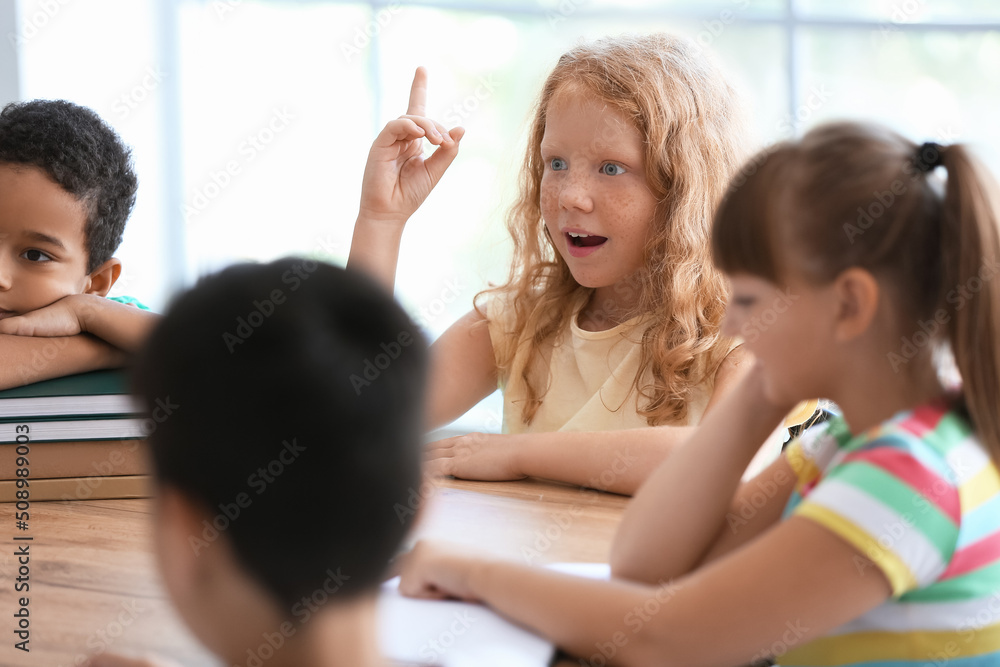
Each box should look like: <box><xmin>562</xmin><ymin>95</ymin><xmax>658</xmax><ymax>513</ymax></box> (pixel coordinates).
<box><xmin>424</xmin><ymin>433</ymin><xmax>525</xmax><ymax>482</ymax></box>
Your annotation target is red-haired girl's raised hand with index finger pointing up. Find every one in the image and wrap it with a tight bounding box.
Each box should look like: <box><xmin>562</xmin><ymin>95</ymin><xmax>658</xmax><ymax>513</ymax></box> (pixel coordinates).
<box><xmin>358</xmin><ymin>67</ymin><xmax>465</xmax><ymax>226</ymax></box>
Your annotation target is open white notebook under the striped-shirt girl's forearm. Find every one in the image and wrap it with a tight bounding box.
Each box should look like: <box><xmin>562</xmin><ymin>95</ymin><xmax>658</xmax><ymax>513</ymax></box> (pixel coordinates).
<box><xmin>378</xmin><ymin>563</ymin><xmax>609</xmax><ymax>667</ymax></box>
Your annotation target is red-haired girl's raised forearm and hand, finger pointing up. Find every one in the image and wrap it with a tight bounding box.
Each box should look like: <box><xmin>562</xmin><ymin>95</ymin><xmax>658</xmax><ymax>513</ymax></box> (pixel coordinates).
<box><xmin>347</xmin><ymin>67</ymin><xmax>465</xmax><ymax>292</ymax></box>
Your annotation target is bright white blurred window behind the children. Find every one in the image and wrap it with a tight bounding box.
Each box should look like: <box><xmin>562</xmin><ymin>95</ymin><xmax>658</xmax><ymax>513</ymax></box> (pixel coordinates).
<box><xmin>0</xmin><ymin>0</ymin><xmax>1000</xmax><ymax>430</ymax></box>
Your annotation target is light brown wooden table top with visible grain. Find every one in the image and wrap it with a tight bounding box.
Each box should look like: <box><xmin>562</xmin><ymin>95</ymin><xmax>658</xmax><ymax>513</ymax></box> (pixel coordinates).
<box><xmin>0</xmin><ymin>480</ymin><xmax>627</xmax><ymax>667</ymax></box>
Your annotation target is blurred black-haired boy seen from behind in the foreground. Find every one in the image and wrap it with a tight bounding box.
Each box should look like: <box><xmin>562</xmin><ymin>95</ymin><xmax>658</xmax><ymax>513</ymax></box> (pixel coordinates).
<box><xmin>92</xmin><ymin>260</ymin><xmax>427</xmax><ymax>667</ymax></box>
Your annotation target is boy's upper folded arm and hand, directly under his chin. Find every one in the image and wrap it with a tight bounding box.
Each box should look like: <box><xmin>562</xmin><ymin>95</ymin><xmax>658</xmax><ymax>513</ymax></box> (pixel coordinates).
<box><xmin>0</xmin><ymin>294</ymin><xmax>159</xmax><ymax>353</ymax></box>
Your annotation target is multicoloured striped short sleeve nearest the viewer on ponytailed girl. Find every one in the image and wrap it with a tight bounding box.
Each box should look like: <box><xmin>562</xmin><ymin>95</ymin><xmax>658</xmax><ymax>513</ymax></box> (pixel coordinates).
<box><xmin>794</xmin><ymin>431</ymin><xmax>961</xmax><ymax>597</ymax></box>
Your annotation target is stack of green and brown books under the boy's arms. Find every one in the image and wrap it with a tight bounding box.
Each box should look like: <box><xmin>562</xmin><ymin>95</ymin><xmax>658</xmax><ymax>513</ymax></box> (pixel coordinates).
<box><xmin>0</xmin><ymin>370</ymin><xmax>152</xmax><ymax>502</ymax></box>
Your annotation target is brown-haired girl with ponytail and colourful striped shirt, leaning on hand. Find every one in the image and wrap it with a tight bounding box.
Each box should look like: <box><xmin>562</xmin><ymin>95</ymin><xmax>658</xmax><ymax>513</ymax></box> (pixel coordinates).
<box><xmin>403</xmin><ymin>123</ymin><xmax>1000</xmax><ymax>667</ymax></box>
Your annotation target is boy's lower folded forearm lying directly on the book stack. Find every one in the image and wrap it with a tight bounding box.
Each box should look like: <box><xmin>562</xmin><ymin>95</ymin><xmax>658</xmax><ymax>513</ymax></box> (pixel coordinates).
<box><xmin>0</xmin><ymin>334</ymin><xmax>126</xmax><ymax>389</ymax></box>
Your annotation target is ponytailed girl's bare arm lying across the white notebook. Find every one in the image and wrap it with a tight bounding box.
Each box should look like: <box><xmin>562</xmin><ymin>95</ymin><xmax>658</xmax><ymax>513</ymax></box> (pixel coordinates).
<box><xmin>400</xmin><ymin>517</ymin><xmax>891</xmax><ymax>667</ymax></box>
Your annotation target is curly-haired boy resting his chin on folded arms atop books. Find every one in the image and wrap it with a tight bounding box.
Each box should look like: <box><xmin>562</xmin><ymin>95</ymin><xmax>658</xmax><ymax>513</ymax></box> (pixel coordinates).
<box><xmin>0</xmin><ymin>100</ymin><xmax>157</xmax><ymax>388</ymax></box>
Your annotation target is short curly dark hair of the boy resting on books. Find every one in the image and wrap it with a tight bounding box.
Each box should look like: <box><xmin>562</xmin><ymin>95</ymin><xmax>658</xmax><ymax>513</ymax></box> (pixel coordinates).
<box><xmin>0</xmin><ymin>100</ymin><xmax>138</xmax><ymax>273</ymax></box>
